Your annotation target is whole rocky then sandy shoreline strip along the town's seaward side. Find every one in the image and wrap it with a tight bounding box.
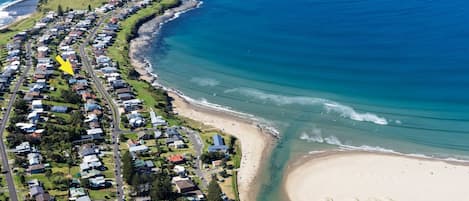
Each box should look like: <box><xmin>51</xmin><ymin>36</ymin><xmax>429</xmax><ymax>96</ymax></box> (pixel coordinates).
<box><xmin>129</xmin><ymin>0</ymin><xmax>279</xmax><ymax>201</ymax></box>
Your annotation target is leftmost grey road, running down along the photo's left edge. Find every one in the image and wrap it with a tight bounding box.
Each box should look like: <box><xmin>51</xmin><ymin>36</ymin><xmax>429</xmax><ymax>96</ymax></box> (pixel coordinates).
<box><xmin>0</xmin><ymin>41</ymin><xmax>32</xmax><ymax>201</ymax></box>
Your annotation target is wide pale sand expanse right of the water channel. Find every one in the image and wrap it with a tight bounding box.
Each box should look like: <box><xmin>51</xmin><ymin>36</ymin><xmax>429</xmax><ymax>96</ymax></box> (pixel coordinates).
<box><xmin>284</xmin><ymin>152</ymin><xmax>469</xmax><ymax>201</ymax></box>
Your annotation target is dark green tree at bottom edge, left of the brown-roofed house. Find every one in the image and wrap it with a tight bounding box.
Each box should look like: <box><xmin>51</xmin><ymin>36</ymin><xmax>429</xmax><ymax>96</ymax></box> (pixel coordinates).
<box><xmin>150</xmin><ymin>172</ymin><xmax>174</xmax><ymax>200</ymax></box>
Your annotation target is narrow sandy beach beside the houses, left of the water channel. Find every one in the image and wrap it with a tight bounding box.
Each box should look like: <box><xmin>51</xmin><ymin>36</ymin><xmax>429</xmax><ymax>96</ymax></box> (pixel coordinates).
<box><xmin>169</xmin><ymin>92</ymin><xmax>274</xmax><ymax>201</ymax></box>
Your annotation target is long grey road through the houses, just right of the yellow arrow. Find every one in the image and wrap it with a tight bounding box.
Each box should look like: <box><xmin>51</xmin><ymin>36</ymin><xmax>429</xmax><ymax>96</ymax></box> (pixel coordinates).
<box><xmin>80</xmin><ymin>14</ymin><xmax>124</xmax><ymax>201</ymax></box>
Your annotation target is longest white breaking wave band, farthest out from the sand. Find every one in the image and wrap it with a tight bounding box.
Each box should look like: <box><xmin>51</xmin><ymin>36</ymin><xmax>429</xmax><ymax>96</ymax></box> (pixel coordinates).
<box><xmin>225</xmin><ymin>88</ymin><xmax>388</xmax><ymax>125</ymax></box>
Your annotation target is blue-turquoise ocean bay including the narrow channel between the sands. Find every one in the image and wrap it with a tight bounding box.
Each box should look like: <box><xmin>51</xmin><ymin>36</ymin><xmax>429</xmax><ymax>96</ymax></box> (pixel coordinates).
<box><xmin>145</xmin><ymin>0</ymin><xmax>469</xmax><ymax>201</ymax></box>
